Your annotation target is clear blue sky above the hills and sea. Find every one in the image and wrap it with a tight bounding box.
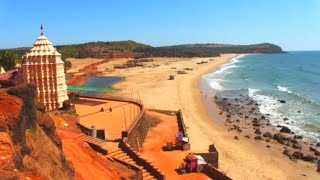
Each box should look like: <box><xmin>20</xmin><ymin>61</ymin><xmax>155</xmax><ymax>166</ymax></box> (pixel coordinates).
<box><xmin>0</xmin><ymin>0</ymin><xmax>320</xmax><ymax>51</ymax></box>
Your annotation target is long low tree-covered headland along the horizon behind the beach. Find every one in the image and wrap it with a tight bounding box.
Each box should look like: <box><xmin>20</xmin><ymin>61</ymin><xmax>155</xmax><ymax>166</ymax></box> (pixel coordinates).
<box><xmin>6</xmin><ymin>41</ymin><xmax>283</xmax><ymax>59</ymax></box>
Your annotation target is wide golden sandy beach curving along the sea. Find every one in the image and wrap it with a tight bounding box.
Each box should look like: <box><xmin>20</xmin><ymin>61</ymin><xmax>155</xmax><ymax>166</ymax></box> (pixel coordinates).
<box><xmin>98</xmin><ymin>54</ymin><xmax>320</xmax><ymax>179</ymax></box>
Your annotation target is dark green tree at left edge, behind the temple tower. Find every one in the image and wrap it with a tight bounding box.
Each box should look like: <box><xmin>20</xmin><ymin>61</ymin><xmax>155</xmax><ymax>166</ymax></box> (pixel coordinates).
<box><xmin>0</xmin><ymin>50</ymin><xmax>19</xmax><ymax>71</ymax></box>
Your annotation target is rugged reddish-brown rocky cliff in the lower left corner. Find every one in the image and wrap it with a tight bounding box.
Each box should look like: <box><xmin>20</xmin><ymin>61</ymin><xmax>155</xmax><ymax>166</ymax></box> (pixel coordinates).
<box><xmin>0</xmin><ymin>84</ymin><xmax>74</xmax><ymax>179</ymax></box>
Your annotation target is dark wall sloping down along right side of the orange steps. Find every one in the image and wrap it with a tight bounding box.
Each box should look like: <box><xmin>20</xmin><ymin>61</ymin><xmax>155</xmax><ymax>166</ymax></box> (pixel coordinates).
<box><xmin>119</xmin><ymin>142</ymin><xmax>166</xmax><ymax>180</ymax></box>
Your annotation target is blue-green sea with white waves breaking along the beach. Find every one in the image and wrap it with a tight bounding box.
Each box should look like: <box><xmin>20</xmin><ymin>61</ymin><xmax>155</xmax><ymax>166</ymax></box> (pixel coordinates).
<box><xmin>202</xmin><ymin>51</ymin><xmax>320</xmax><ymax>140</ymax></box>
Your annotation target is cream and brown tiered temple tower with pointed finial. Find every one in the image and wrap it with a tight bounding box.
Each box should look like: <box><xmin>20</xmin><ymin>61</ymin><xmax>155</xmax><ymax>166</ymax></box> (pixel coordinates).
<box><xmin>22</xmin><ymin>25</ymin><xmax>68</xmax><ymax>111</ymax></box>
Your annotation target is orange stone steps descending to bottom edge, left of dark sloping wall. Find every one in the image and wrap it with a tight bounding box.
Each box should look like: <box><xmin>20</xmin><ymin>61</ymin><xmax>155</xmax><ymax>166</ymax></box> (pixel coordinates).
<box><xmin>106</xmin><ymin>149</ymin><xmax>156</xmax><ymax>180</ymax></box>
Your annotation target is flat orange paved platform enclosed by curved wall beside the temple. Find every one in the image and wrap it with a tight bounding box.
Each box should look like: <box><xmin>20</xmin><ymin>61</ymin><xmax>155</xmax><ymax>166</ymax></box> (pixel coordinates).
<box><xmin>75</xmin><ymin>98</ymin><xmax>140</xmax><ymax>140</ymax></box>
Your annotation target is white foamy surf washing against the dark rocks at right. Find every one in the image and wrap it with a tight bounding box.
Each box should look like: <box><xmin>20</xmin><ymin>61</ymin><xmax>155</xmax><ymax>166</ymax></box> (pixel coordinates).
<box><xmin>248</xmin><ymin>88</ymin><xmax>319</xmax><ymax>139</ymax></box>
